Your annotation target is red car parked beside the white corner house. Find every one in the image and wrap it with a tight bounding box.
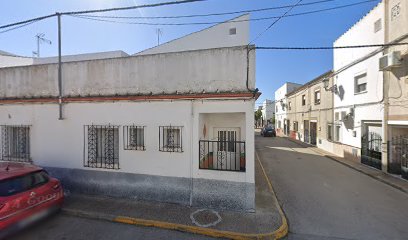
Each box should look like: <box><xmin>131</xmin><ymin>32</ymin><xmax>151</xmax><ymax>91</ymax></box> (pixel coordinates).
<box><xmin>0</xmin><ymin>162</ymin><xmax>64</xmax><ymax>236</ymax></box>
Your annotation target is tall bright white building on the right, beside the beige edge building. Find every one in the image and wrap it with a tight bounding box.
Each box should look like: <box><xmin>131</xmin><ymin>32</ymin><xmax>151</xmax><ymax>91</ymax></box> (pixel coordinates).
<box><xmin>333</xmin><ymin>2</ymin><xmax>385</xmax><ymax>168</ymax></box>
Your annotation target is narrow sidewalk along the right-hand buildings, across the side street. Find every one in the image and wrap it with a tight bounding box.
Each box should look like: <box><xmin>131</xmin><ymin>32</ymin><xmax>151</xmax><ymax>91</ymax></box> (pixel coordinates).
<box><xmin>285</xmin><ymin>137</ymin><xmax>408</xmax><ymax>194</ymax></box>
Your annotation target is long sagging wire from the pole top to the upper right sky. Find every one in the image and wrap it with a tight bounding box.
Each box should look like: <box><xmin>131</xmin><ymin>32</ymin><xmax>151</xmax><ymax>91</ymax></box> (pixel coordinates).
<box><xmin>70</xmin><ymin>0</ymin><xmax>378</xmax><ymax>26</ymax></box>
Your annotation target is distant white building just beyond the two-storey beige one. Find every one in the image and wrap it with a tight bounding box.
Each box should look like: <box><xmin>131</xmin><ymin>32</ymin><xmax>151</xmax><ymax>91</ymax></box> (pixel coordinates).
<box><xmin>275</xmin><ymin>82</ymin><xmax>302</xmax><ymax>135</ymax></box>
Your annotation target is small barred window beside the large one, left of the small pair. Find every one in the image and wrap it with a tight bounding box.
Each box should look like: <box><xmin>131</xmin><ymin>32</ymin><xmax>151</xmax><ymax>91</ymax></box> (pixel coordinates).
<box><xmin>123</xmin><ymin>125</ymin><xmax>146</xmax><ymax>151</ymax></box>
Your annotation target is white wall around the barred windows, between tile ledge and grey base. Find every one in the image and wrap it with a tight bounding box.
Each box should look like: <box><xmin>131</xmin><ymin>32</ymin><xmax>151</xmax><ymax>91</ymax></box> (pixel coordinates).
<box><xmin>0</xmin><ymin>100</ymin><xmax>255</xmax><ymax>183</ymax></box>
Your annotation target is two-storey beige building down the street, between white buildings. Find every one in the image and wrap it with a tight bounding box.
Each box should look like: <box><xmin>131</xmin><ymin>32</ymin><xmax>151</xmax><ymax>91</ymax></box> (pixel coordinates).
<box><xmin>285</xmin><ymin>71</ymin><xmax>334</xmax><ymax>151</ymax></box>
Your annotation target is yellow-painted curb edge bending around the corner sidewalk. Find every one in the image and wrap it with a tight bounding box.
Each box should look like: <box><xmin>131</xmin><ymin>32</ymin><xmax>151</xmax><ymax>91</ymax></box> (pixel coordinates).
<box><xmin>108</xmin><ymin>151</ymin><xmax>288</xmax><ymax>240</ymax></box>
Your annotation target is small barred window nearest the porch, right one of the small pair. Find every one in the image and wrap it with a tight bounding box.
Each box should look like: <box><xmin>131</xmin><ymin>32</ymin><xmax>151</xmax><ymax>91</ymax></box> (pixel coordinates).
<box><xmin>159</xmin><ymin>126</ymin><xmax>183</xmax><ymax>152</ymax></box>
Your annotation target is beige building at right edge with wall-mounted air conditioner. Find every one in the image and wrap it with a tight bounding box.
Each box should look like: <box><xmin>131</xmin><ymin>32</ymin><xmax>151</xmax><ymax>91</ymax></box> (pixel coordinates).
<box><xmin>381</xmin><ymin>0</ymin><xmax>408</xmax><ymax>179</ymax></box>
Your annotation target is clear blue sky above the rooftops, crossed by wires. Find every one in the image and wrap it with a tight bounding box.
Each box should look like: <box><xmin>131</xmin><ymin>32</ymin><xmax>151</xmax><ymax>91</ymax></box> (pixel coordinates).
<box><xmin>0</xmin><ymin>0</ymin><xmax>380</xmax><ymax>104</ymax></box>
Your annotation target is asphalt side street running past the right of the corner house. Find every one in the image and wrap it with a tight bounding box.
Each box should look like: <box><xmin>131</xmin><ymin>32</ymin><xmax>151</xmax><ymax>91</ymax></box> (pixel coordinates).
<box><xmin>255</xmin><ymin>135</ymin><xmax>408</xmax><ymax>240</ymax></box>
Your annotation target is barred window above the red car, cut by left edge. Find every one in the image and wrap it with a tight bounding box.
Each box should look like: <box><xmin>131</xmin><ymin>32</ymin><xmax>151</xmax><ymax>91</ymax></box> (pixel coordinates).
<box><xmin>0</xmin><ymin>125</ymin><xmax>31</xmax><ymax>162</ymax></box>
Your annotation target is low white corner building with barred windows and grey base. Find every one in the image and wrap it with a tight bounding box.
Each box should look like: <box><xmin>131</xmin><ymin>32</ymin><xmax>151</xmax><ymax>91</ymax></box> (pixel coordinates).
<box><xmin>0</xmin><ymin>15</ymin><xmax>257</xmax><ymax>210</ymax></box>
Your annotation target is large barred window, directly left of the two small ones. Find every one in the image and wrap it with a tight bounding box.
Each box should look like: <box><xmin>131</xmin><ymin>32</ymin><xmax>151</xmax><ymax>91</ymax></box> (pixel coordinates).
<box><xmin>84</xmin><ymin>125</ymin><xmax>119</xmax><ymax>169</ymax></box>
